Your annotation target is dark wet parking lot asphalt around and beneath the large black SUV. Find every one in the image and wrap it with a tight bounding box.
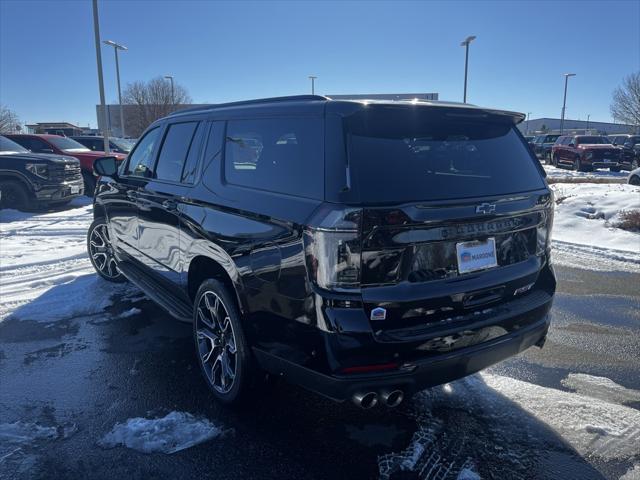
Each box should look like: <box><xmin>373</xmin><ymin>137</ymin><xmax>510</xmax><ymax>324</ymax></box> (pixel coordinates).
<box><xmin>0</xmin><ymin>260</ymin><xmax>640</xmax><ymax>480</ymax></box>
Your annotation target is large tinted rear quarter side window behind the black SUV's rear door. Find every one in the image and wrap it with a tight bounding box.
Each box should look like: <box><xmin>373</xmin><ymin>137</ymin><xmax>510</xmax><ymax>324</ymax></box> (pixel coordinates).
<box><xmin>225</xmin><ymin>118</ymin><xmax>324</xmax><ymax>199</ymax></box>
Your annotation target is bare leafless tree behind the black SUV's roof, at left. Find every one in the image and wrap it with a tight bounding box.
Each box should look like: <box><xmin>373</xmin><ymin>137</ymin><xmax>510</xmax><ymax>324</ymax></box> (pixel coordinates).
<box><xmin>122</xmin><ymin>77</ymin><xmax>191</xmax><ymax>137</ymax></box>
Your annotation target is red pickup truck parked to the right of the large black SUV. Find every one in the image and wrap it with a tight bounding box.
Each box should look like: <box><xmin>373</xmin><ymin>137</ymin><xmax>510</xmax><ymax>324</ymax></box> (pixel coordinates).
<box><xmin>551</xmin><ymin>135</ymin><xmax>621</xmax><ymax>172</ymax></box>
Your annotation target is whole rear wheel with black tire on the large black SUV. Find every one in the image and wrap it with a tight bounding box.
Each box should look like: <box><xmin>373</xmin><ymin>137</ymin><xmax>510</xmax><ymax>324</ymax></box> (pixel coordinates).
<box><xmin>193</xmin><ymin>279</ymin><xmax>257</xmax><ymax>406</ymax></box>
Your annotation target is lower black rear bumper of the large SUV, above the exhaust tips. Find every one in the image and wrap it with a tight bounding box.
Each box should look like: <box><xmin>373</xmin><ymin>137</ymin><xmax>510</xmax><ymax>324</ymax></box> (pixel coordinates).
<box><xmin>254</xmin><ymin>314</ymin><xmax>549</xmax><ymax>402</ymax></box>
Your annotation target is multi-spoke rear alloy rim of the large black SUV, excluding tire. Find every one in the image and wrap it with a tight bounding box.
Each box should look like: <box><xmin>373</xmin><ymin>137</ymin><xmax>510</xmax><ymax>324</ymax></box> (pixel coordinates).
<box><xmin>196</xmin><ymin>290</ymin><xmax>238</xmax><ymax>394</ymax></box>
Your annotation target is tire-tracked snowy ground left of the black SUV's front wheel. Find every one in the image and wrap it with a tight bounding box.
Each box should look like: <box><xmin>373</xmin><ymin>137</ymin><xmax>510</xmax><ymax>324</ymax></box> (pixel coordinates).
<box><xmin>0</xmin><ymin>198</ymin><xmax>131</xmax><ymax>321</ymax></box>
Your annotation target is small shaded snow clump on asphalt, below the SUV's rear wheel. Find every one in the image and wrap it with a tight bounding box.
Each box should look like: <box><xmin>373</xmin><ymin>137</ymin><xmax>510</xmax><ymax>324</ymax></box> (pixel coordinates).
<box><xmin>98</xmin><ymin>412</ymin><xmax>225</xmax><ymax>453</ymax></box>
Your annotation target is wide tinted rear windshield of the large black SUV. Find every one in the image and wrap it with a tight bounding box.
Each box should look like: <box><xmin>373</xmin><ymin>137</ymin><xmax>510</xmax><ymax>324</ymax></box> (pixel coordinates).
<box><xmin>345</xmin><ymin>106</ymin><xmax>544</xmax><ymax>203</ymax></box>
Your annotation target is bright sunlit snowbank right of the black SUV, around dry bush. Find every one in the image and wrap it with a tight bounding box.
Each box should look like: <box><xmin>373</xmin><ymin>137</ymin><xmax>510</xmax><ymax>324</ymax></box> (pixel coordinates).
<box><xmin>552</xmin><ymin>183</ymin><xmax>640</xmax><ymax>262</ymax></box>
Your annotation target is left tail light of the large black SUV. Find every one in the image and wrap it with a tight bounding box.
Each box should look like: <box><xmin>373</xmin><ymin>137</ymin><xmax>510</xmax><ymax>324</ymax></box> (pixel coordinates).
<box><xmin>304</xmin><ymin>209</ymin><xmax>362</xmax><ymax>290</ymax></box>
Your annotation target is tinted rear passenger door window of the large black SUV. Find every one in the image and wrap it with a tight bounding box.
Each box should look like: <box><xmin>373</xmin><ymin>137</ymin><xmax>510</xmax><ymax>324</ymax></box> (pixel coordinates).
<box><xmin>155</xmin><ymin>122</ymin><xmax>198</xmax><ymax>182</ymax></box>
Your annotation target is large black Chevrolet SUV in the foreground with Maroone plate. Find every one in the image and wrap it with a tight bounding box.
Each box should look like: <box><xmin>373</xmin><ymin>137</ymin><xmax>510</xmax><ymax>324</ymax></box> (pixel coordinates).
<box><xmin>88</xmin><ymin>96</ymin><xmax>556</xmax><ymax>407</ymax></box>
